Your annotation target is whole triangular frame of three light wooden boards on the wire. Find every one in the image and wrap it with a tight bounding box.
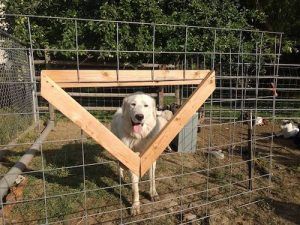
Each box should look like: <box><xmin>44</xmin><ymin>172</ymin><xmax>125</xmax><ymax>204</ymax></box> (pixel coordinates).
<box><xmin>41</xmin><ymin>70</ymin><xmax>216</xmax><ymax>176</ymax></box>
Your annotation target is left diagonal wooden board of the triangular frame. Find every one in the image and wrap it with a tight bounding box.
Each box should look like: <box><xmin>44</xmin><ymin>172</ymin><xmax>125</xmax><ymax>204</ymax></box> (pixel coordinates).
<box><xmin>41</xmin><ymin>75</ymin><xmax>140</xmax><ymax>175</ymax></box>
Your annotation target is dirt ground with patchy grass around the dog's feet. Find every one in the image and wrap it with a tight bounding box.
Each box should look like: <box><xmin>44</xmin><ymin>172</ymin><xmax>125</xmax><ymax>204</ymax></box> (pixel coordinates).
<box><xmin>0</xmin><ymin>118</ymin><xmax>300</xmax><ymax>225</ymax></box>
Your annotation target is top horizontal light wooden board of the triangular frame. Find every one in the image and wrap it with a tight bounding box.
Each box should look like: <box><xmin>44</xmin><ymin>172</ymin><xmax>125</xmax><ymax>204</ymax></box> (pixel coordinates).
<box><xmin>42</xmin><ymin>70</ymin><xmax>209</xmax><ymax>88</ymax></box>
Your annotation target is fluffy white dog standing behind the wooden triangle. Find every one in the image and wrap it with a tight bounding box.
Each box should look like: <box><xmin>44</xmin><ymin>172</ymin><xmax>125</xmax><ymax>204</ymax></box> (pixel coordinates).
<box><xmin>111</xmin><ymin>93</ymin><xmax>171</xmax><ymax>215</ymax></box>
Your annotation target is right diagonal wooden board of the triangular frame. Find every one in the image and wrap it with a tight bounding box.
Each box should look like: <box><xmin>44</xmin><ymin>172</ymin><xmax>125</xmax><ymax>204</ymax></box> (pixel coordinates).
<box><xmin>141</xmin><ymin>71</ymin><xmax>216</xmax><ymax>176</ymax></box>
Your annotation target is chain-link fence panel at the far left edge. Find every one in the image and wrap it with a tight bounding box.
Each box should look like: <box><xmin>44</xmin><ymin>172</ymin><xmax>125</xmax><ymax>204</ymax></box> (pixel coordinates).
<box><xmin>0</xmin><ymin>29</ymin><xmax>35</xmax><ymax>145</ymax></box>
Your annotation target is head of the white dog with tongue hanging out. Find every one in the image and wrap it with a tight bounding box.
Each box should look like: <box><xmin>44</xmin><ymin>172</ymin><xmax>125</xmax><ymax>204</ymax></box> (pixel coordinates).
<box><xmin>122</xmin><ymin>93</ymin><xmax>156</xmax><ymax>138</ymax></box>
